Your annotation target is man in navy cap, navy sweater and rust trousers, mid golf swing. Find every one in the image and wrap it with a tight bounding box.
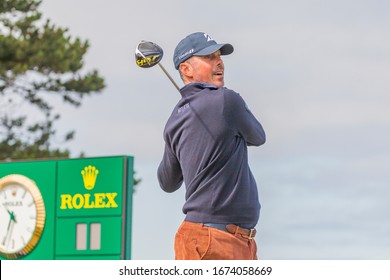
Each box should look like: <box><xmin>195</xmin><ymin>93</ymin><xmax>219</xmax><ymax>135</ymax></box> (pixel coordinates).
<box><xmin>157</xmin><ymin>32</ymin><xmax>265</xmax><ymax>260</ymax></box>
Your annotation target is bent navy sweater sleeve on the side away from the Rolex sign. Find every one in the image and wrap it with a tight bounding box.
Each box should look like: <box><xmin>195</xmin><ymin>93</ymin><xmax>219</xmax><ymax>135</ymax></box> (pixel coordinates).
<box><xmin>224</xmin><ymin>90</ymin><xmax>266</xmax><ymax>146</ymax></box>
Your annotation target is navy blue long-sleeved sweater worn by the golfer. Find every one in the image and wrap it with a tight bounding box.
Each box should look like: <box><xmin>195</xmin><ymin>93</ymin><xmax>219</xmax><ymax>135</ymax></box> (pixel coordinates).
<box><xmin>157</xmin><ymin>83</ymin><xmax>265</xmax><ymax>225</ymax></box>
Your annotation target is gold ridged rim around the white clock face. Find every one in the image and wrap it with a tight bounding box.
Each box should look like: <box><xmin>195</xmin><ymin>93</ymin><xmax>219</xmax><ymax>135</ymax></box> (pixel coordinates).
<box><xmin>0</xmin><ymin>174</ymin><xmax>46</xmax><ymax>259</ymax></box>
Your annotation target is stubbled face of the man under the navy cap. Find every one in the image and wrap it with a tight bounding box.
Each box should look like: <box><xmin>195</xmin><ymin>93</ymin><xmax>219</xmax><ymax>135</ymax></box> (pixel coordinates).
<box><xmin>187</xmin><ymin>51</ymin><xmax>225</xmax><ymax>87</ymax></box>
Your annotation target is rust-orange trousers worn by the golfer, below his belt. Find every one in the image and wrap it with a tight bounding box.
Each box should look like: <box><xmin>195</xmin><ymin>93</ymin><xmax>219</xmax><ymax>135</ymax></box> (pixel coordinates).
<box><xmin>175</xmin><ymin>221</ymin><xmax>257</xmax><ymax>260</ymax></box>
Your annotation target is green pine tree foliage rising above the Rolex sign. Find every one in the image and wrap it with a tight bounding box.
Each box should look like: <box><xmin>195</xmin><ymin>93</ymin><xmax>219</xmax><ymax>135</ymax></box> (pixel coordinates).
<box><xmin>0</xmin><ymin>0</ymin><xmax>105</xmax><ymax>160</ymax></box>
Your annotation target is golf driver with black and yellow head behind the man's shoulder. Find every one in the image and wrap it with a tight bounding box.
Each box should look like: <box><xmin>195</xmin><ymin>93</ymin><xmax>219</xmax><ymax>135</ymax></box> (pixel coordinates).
<box><xmin>135</xmin><ymin>41</ymin><xmax>180</xmax><ymax>92</ymax></box>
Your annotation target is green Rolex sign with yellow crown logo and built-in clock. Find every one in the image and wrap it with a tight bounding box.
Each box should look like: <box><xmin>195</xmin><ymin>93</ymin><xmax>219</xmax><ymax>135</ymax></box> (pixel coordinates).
<box><xmin>0</xmin><ymin>156</ymin><xmax>133</xmax><ymax>259</ymax></box>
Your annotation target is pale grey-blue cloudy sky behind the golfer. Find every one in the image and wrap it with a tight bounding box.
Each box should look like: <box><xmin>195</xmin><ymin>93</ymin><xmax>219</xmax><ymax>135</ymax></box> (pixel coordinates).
<box><xmin>36</xmin><ymin>0</ymin><xmax>390</xmax><ymax>260</ymax></box>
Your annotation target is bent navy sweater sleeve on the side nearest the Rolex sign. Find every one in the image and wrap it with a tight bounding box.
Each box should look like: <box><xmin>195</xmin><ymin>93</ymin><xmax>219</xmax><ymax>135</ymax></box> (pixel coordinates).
<box><xmin>157</xmin><ymin>142</ymin><xmax>183</xmax><ymax>192</ymax></box>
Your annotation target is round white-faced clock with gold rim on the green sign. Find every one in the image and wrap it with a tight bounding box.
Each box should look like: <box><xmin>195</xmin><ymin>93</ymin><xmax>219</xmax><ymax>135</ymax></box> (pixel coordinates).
<box><xmin>0</xmin><ymin>174</ymin><xmax>46</xmax><ymax>259</ymax></box>
